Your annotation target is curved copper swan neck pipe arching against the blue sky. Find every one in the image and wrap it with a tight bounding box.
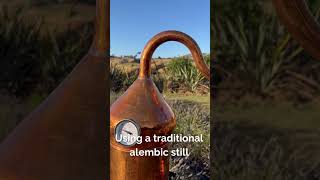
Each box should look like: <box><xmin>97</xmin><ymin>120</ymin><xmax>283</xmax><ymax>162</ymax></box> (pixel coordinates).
<box><xmin>139</xmin><ymin>31</ymin><xmax>210</xmax><ymax>80</ymax></box>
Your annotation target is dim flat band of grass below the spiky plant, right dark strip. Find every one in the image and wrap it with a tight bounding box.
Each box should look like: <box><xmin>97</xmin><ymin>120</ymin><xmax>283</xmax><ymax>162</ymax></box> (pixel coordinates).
<box><xmin>214</xmin><ymin>103</ymin><xmax>320</xmax><ymax>130</ymax></box>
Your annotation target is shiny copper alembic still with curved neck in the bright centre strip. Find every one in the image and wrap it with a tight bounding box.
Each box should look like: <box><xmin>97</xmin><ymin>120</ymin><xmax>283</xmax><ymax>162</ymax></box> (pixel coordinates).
<box><xmin>110</xmin><ymin>31</ymin><xmax>210</xmax><ymax>180</ymax></box>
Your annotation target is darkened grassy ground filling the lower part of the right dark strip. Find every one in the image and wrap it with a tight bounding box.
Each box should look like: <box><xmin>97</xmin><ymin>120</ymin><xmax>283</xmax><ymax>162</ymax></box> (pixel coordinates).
<box><xmin>211</xmin><ymin>102</ymin><xmax>320</xmax><ymax>180</ymax></box>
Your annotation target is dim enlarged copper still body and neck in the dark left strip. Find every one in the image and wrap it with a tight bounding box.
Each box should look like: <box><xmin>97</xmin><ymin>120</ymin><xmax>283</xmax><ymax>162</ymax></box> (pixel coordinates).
<box><xmin>0</xmin><ymin>0</ymin><xmax>110</xmax><ymax>180</ymax></box>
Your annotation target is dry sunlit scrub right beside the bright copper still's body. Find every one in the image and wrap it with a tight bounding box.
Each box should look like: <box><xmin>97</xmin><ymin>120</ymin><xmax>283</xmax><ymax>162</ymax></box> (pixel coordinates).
<box><xmin>169</xmin><ymin>101</ymin><xmax>210</xmax><ymax>179</ymax></box>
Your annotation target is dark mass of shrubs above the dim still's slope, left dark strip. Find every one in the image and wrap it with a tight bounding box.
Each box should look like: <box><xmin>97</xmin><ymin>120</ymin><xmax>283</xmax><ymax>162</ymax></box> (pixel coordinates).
<box><xmin>0</xmin><ymin>6</ymin><xmax>93</xmax><ymax>97</ymax></box>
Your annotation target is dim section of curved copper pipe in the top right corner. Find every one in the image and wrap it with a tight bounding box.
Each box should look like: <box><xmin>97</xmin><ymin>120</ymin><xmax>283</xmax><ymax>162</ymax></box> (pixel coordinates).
<box><xmin>273</xmin><ymin>0</ymin><xmax>320</xmax><ymax>60</ymax></box>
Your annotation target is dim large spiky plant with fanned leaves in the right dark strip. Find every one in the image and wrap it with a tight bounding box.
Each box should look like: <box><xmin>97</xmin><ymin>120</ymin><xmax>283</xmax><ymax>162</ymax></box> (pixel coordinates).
<box><xmin>212</xmin><ymin>16</ymin><xmax>302</xmax><ymax>93</ymax></box>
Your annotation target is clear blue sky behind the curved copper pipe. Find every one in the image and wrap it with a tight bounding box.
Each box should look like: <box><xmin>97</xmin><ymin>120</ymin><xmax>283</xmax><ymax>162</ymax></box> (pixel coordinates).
<box><xmin>110</xmin><ymin>0</ymin><xmax>210</xmax><ymax>57</ymax></box>
